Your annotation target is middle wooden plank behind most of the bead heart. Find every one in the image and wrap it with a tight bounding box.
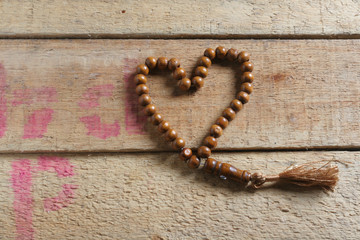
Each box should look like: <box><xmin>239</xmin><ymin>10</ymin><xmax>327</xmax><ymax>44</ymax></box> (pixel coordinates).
<box><xmin>0</xmin><ymin>40</ymin><xmax>360</xmax><ymax>152</ymax></box>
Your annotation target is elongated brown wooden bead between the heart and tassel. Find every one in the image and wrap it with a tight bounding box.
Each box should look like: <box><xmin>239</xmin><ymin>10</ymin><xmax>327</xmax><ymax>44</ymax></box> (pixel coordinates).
<box><xmin>204</xmin><ymin>158</ymin><xmax>251</xmax><ymax>183</ymax></box>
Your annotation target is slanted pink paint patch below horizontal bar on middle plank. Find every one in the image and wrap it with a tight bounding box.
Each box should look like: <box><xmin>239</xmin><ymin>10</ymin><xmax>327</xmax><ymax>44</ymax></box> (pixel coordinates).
<box><xmin>23</xmin><ymin>108</ymin><xmax>54</xmax><ymax>139</ymax></box>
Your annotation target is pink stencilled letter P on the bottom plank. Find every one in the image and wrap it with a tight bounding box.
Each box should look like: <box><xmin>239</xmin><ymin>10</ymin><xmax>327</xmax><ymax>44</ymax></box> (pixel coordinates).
<box><xmin>11</xmin><ymin>156</ymin><xmax>78</xmax><ymax>240</ymax></box>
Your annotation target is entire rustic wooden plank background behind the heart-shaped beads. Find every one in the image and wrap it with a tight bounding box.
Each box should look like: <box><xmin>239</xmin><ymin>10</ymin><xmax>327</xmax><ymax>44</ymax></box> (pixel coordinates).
<box><xmin>0</xmin><ymin>0</ymin><xmax>360</xmax><ymax>239</ymax></box>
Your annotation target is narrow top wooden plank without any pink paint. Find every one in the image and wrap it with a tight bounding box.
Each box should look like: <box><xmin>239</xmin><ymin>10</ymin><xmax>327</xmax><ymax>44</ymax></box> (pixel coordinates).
<box><xmin>0</xmin><ymin>0</ymin><xmax>360</xmax><ymax>38</ymax></box>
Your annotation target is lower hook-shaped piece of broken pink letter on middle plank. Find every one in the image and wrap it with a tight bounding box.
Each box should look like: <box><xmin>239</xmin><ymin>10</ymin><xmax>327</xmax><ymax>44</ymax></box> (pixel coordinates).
<box><xmin>80</xmin><ymin>114</ymin><xmax>120</xmax><ymax>139</ymax></box>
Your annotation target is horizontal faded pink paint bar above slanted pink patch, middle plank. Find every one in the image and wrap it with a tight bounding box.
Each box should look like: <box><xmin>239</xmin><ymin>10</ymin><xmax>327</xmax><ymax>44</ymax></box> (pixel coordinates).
<box><xmin>12</xmin><ymin>87</ymin><xmax>57</xmax><ymax>106</ymax></box>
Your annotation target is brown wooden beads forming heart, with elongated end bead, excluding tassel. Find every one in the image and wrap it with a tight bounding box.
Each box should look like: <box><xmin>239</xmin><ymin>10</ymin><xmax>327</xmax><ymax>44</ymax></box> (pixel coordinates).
<box><xmin>134</xmin><ymin>46</ymin><xmax>254</xmax><ymax>185</ymax></box>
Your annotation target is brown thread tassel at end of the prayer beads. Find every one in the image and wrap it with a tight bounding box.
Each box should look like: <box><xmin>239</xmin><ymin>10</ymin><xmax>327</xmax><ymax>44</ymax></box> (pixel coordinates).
<box><xmin>251</xmin><ymin>160</ymin><xmax>344</xmax><ymax>191</ymax></box>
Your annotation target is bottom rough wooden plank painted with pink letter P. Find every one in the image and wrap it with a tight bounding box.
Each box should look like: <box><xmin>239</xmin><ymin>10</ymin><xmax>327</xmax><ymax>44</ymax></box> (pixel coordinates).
<box><xmin>0</xmin><ymin>151</ymin><xmax>360</xmax><ymax>239</ymax></box>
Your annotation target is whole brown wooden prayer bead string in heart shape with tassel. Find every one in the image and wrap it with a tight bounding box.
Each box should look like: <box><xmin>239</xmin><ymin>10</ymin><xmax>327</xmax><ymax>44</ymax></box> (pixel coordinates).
<box><xmin>134</xmin><ymin>46</ymin><xmax>338</xmax><ymax>190</ymax></box>
